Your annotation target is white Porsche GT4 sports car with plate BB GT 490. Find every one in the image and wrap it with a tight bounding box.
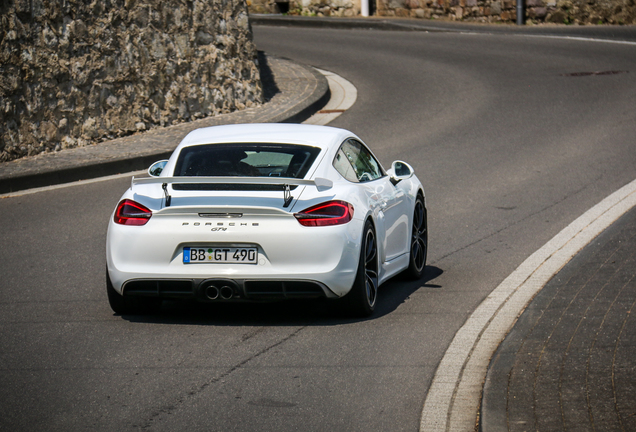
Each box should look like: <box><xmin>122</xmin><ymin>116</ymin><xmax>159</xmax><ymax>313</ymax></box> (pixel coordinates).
<box><xmin>106</xmin><ymin>124</ymin><xmax>428</xmax><ymax>316</ymax></box>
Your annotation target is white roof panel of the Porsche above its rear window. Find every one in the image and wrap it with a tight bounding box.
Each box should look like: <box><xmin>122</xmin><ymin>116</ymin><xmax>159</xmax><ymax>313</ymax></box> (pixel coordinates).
<box><xmin>177</xmin><ymin>123</ymin><xmax>359</xmax><ymax>150</ymax></box>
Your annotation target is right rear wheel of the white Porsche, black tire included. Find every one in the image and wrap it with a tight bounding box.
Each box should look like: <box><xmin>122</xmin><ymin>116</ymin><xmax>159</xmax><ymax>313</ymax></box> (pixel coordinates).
<box><xmin>344</xmin><ymin>221</ymin><xmax>378</xmax><ymax>317</ymax></box>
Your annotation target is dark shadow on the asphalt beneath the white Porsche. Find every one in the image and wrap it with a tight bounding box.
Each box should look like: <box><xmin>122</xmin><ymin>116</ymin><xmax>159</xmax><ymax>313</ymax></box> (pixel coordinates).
<box><xmin>121</xmin><ymin>266</ymin><xmax>443</xmax><ymax>327</ymax></box>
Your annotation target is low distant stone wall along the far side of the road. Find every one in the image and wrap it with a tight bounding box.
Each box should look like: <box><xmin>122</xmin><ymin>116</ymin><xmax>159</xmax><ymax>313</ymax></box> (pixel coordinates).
<box><xmin>248</xmin><ymin>0</ymin><xmax>636</xmax><ymax>24</ymax></box>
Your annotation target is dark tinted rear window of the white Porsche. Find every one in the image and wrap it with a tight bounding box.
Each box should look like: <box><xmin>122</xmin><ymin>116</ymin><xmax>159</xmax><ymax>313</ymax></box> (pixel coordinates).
<box><xmin>174</xmin><ymin>143</ymin><xmax>320</xmax><ymax>190</ymax></box>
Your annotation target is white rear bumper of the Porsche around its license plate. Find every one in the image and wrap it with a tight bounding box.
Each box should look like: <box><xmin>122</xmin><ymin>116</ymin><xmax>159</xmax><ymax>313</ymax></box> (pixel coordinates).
<box><xmin>106</xmin><ymin>215</ymin><xmax>362</xmax><ymax>300</ymax></box>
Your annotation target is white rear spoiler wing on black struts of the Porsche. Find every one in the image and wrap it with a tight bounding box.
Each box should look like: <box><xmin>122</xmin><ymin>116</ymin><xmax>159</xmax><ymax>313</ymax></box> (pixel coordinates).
<box><xmin>130</xmin><ymin>177</ymin><xmax>333</xmax><ymax>207</ymax></box>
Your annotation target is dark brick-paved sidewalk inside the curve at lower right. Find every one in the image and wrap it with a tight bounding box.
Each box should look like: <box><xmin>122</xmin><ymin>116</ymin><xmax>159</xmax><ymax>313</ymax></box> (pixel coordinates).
<box><xmin>480</xmin><ymin>208</ymin><xmax>636</xmax><ymax>432</ymax></box>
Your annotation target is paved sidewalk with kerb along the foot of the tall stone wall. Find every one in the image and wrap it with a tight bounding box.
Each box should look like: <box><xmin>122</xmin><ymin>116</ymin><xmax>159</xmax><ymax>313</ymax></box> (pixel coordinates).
<box><xmin>0</xmin><ymin>56</ymin><xmax>329</xmax><ymax>194</ymax></box>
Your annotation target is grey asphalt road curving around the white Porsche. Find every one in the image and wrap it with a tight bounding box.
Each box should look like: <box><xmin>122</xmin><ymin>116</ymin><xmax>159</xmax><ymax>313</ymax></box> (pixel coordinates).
<box><xmin>0</xmin><ymin>27</ymin><xmax>636</xmax><ymax>431</ymax></box>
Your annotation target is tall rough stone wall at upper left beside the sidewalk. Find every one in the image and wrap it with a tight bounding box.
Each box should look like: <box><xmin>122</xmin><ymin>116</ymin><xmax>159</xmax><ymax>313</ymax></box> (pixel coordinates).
<box><xmin>0</xmin><ymin>0</ymin><xmax>263</xmax><ymax>161</ymax></box>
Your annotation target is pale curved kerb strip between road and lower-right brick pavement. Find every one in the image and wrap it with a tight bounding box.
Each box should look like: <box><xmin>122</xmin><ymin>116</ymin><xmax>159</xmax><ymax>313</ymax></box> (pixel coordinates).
<box><xmin>420</xmin><ymin>180</ymin><xmax>636</xmax><ymax>432</ymax></box>
